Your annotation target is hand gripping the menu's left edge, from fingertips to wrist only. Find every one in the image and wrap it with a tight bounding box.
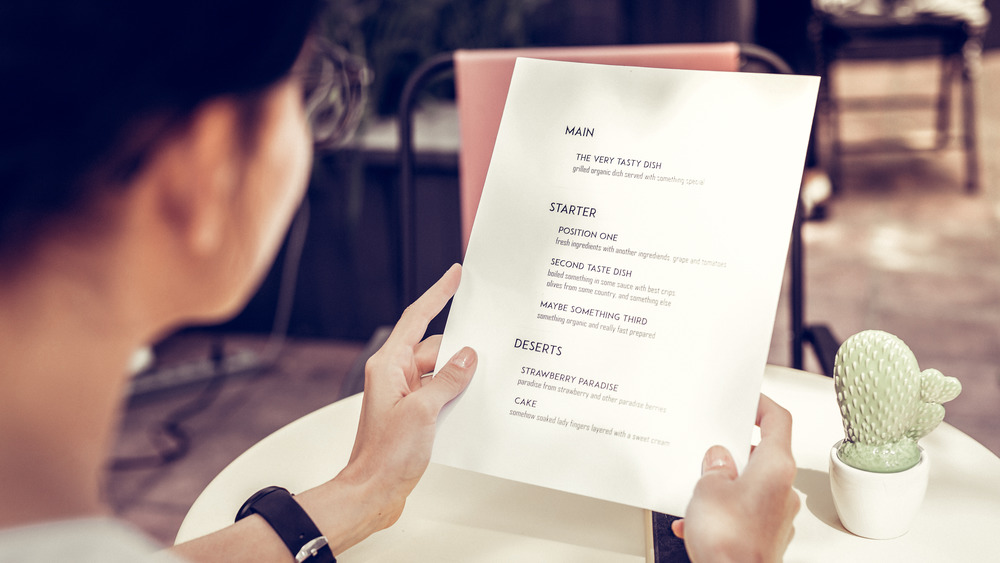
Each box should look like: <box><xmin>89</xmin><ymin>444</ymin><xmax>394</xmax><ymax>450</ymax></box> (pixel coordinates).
<box><xmin>338</xmin><ymin>264</ymin><xmax>476</xmax><ymax>527</ymax></box>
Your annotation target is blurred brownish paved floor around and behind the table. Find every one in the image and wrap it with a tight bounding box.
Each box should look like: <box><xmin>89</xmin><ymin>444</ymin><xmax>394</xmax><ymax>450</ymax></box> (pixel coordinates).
<box><xmin>107</xmin><ymin>54</ymin><xmax>1000</xmax><ymax>542</ymax></box>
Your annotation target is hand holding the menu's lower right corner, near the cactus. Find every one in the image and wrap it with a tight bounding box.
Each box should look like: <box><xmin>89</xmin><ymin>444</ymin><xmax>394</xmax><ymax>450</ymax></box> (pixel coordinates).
<box><xmin>673</xmin><ymin>395</ymin><xmax>800</xmax><ymax>562</ymax></box>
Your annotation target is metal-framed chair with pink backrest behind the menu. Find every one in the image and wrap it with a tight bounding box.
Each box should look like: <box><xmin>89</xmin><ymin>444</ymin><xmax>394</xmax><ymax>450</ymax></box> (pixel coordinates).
<box><xmin>386</xmin><ymin>43</ymin><xmax>839</xmax><ymax>375</ymax></box>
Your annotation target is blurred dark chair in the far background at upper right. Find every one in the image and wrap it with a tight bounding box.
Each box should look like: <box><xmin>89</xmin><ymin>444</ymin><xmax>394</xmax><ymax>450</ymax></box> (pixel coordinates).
<box><xmin>810</xmin><ymin>0</ymin><xmax>990</xmax><ymax>193</ymax></box>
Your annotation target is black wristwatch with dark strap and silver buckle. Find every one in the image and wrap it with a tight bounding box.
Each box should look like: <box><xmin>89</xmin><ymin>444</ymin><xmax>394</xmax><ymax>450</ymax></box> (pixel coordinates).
<box><xmin>236</xmin><ymin>487</ymin><xmax>337</xmax><ymax>563</ymax></box>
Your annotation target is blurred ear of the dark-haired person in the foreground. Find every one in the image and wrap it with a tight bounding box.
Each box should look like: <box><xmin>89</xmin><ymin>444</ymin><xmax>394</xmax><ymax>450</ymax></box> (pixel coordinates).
<box><xmin>146</xmin><ymin>98</ymin><xmax>245</xmax><ymax>258</ymax></box>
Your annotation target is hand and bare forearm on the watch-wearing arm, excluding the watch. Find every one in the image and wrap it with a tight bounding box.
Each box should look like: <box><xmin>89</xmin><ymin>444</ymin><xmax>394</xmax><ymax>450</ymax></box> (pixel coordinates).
<box><xmin>175</xmin><ymin>265</ymin><xmax>476</xmax><ymax>561</ymax></box>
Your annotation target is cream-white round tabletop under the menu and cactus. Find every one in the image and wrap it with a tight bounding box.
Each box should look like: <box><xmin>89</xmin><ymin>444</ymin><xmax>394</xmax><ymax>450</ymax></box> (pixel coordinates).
<box><xmin>177</xmin><ymin>366</ymin><xmax>1000</xmax><ymax>563</ymax></box>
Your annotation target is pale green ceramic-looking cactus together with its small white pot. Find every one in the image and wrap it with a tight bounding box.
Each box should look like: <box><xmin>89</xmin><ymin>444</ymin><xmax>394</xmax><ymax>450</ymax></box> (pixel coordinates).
<box><xmin>830</xmin><ymin>330</ymin><xmax>962</xmax><ymax>539</ymax></box>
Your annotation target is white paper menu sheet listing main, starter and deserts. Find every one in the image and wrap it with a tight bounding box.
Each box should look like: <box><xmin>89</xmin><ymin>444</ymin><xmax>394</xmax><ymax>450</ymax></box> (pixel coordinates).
<box><xmin>432</xmin><ymin>59</ymin><xmax>818</xmax><ymax>515</ymax></box>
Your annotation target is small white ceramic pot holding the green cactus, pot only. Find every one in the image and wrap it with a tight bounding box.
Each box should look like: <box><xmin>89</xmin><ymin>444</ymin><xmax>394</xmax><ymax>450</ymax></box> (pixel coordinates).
<box><xmin>830</xmin><ymin>442</ymin><xmax>930</xmax><ymax>540</ymax></box>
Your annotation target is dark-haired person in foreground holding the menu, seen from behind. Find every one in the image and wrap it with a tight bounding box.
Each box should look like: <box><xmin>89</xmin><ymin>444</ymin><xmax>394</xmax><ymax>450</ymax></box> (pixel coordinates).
<box><xmin>0</xmin><ymin>0</ymin><xmax>798</xmax><ymax>562</ymax></box>
